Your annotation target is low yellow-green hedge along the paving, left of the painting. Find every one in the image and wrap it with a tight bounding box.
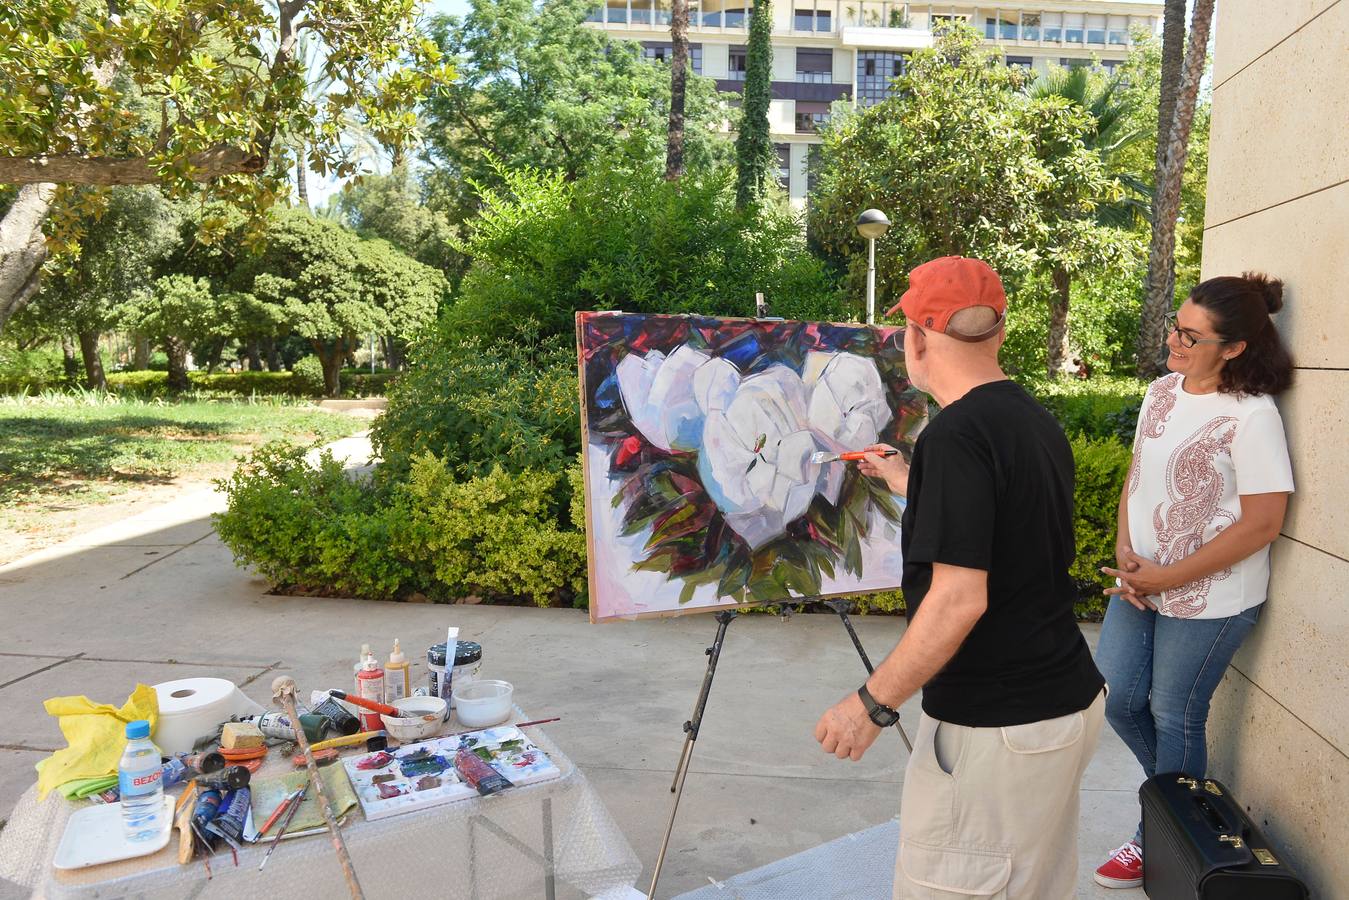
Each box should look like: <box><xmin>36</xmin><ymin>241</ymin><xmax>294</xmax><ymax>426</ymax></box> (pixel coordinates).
<box><xmin>214</xmin><ymin>443</ymin><xmax>585</xmax><ymax>606</ymax></box>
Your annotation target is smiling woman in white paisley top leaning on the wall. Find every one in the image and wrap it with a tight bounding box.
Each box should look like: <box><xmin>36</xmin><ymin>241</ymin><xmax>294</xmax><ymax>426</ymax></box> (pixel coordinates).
<box><xmin>1095</xmin><ymin>273</ymin><xmax>1292</xmax><ymax>888</ymax></box>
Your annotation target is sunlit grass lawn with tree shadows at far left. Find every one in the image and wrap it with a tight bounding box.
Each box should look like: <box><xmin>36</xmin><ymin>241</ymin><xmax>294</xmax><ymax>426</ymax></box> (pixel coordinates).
<box><xmin>0</xmin><ymin>394</ymin><xmax>367</xmax><ymax>555</ymax></box>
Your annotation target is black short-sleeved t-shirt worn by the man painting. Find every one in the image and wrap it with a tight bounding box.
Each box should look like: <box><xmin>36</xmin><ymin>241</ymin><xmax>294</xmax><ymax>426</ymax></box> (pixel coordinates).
<box><xmin>901</xmin><ymin>381</ymin><xmax>1105</xmax><ymax>727</ymax></box>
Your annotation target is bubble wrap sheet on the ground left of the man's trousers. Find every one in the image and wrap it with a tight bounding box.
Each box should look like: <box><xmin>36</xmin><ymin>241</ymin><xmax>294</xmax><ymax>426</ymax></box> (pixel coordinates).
<box><xmin>676</xmin><ymin>819</ymin><xmax>900</xmax><ymax>900</ymax></box>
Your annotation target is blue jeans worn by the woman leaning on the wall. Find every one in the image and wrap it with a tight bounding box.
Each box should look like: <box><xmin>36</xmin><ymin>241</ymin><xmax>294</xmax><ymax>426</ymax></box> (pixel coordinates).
<box><xmin>1097</xmin><ymin>596</ymin><xmax>1261</xmax><ymax>845</ymax></box>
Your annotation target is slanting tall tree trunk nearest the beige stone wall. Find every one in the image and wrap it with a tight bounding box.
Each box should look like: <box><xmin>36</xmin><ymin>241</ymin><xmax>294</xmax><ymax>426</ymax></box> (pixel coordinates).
<box><xmin>1139</xmin><ymin>0</ymin><xmax>1213</xmax><ymax>378</ymax></box>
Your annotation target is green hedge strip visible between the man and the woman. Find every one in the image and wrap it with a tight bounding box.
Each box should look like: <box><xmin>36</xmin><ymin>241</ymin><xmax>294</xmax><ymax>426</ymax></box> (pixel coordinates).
<box><xmin>1068</xmin><ymin>434</ymin><xmax>1132</xmax><ymax>618</ymax></box>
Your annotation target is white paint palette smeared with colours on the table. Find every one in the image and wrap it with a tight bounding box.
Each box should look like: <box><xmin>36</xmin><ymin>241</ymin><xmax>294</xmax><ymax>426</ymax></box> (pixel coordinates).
<box><xmin>343</xmin><ymin>725</ymin><xmax>561</xmax><ymax>819</ymax></box>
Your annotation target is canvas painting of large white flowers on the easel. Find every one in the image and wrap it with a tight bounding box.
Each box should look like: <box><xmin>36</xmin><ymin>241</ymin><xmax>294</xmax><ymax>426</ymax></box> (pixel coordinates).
<box><xmin>576</xmin><ymin>313</ymin><xmax>927</xmax><ymax>621</ymax></box>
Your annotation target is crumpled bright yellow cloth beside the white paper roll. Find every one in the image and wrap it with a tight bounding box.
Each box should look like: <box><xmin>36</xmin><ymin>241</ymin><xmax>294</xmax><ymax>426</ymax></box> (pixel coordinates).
<box><xmin>38</xmin><ymin>684</ymin><xmax>159</xmax><ymax>799</ymax></box>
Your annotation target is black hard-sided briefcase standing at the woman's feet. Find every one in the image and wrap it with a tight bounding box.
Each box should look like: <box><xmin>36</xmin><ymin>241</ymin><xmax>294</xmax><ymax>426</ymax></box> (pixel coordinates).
<box><xmin>1139</xmin><ymin>772</ymin><xmax>1309</xmax><ymax>900</ymax></box>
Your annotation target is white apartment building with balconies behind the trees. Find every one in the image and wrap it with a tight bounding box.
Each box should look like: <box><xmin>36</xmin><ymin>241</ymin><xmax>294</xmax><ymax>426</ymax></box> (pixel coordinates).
<box><xmin>590</xmin><ymin>0</ymin><xmax>1161</xmax><ymax>208</ymax></box>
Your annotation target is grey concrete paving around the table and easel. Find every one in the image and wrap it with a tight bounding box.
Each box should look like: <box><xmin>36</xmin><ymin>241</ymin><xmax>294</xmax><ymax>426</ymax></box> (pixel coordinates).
<box><xmin>0</xmin><ymin>439</ymin><xmax>1141</xmax><ymax>897</ymax></box>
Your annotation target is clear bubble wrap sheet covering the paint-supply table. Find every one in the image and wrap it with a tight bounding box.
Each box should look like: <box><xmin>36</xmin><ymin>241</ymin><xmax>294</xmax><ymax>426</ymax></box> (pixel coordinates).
<box><xmin>0</xmin><ymin>729</ymin><xmax>642</xmax><ymax>900</ymax></box>
